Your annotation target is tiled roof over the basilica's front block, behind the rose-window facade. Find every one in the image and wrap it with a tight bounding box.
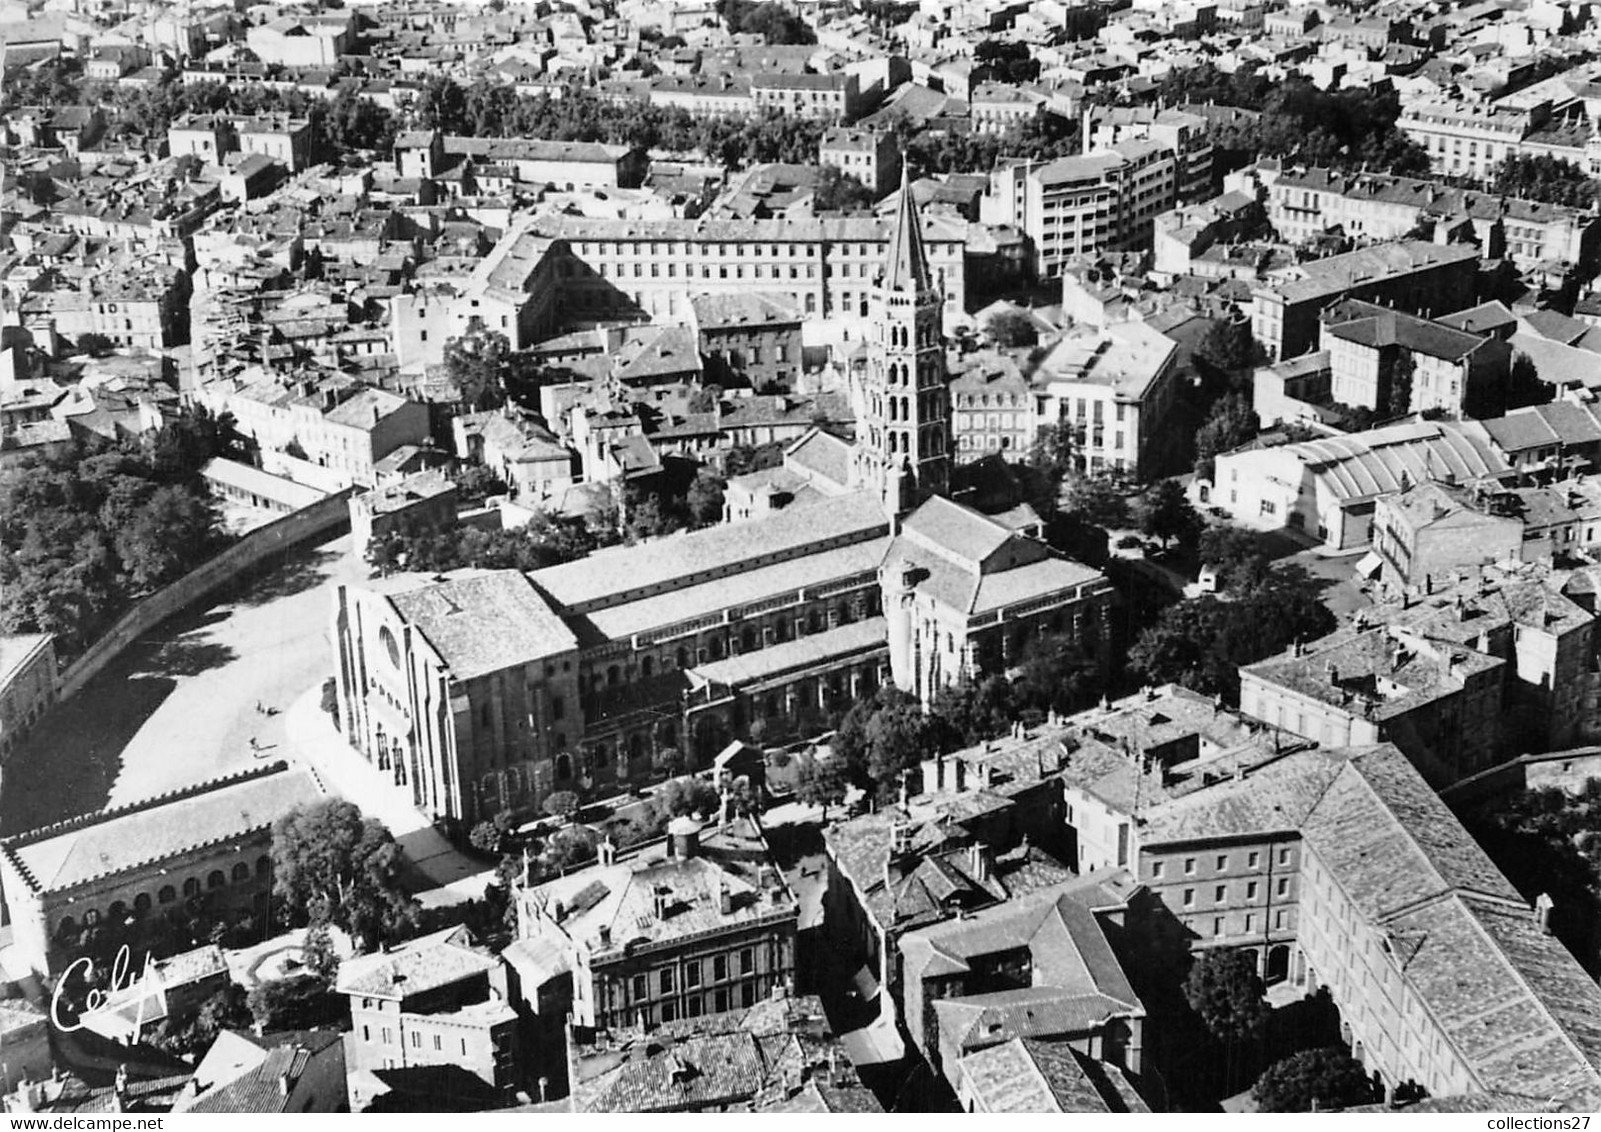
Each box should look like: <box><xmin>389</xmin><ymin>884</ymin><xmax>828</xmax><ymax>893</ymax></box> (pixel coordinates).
<box><xmin>386</xmin><ymin>570</ymin><xmax>578</xmax><ymax>680</ymax></box>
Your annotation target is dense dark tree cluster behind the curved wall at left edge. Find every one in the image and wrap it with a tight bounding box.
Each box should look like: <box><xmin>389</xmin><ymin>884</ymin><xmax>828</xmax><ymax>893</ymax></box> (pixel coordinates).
<box><xmin>0</xmin><ymin>408</ymin><xmax>243</xmax><ymax>656</ymax></box>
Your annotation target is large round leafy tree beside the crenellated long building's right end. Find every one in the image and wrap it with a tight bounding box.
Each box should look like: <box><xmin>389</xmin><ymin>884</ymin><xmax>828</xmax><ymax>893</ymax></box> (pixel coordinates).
<box><xmin>272</xmin><ymin>799</ymin><xmax>418</xmax><ymax>949</ymax></box>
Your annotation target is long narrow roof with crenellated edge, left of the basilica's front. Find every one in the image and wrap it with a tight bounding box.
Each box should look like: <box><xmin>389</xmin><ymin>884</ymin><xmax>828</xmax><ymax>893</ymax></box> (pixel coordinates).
<box><xmin>0</xmin><ymin>762</ymin><xmax>323</xmax><ymax>892</ymax></box>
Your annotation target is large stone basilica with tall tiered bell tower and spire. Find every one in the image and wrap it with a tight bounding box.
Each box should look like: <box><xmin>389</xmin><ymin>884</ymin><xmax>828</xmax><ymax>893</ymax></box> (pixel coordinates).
<box><xmin>333</xmin><ymin>176</ymin><xmax>1113</xmax><ymax>829</ymax></box>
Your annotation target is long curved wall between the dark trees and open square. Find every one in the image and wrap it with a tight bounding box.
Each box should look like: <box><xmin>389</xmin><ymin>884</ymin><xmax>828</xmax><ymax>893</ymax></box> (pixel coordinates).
<box><xmin>58</xmin><ymin>488</ymin><xmax>355</xmax><ymax>703</ymax></box>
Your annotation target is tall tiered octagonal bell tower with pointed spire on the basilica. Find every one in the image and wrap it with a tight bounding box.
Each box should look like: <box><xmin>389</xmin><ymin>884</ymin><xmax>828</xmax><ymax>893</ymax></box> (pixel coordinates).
<box><xmin>852</xmin><ymin>162</ymin><xmax>951</xmax><ymax>516</ymax></box>
